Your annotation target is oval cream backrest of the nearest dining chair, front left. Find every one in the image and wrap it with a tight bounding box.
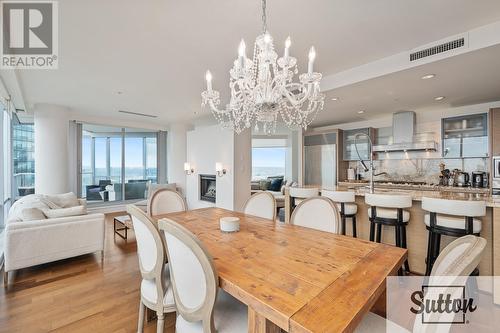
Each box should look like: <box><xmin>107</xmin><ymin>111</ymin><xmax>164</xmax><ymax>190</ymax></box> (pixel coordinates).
<box><xmin>158</xmin><ymin>218</ymin><xmax>218</xmax><ymax>332</ymax></box>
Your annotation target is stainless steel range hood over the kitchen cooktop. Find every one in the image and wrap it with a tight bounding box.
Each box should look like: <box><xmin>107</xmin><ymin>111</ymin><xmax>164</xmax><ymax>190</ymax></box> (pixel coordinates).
<box><xmin>373</xmin><ymin>111</ymin><xmax>437</xmax><ymax>153</ymax></box>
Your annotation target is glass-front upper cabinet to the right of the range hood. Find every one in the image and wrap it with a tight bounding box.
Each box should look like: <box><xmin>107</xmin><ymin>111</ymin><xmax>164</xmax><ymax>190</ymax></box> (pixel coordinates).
<box><xmin>441</xmin><ymin>113</ymin><xmax>488</xmax><ymax>158</ymax></box>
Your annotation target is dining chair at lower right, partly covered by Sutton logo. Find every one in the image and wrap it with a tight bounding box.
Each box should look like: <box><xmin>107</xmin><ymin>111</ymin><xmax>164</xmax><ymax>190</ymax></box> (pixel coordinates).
<box><xmin>354</xmin><ymin>235</ymin><xmax>487</xmax><ymax>333</ymax></box>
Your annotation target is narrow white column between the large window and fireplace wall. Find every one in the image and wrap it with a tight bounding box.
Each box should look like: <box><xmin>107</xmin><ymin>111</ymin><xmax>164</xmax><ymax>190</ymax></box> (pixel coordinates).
<box><xmin>167</xmin><ymin>124</ymin><xmax>189</xmax><ymax>194</ymax></box>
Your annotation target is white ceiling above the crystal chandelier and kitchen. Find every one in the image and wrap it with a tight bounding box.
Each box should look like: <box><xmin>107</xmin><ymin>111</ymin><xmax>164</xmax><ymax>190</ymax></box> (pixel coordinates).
<box><xmin>7</xmin><ymin>0</ymin><xmax>500</xmax><ymax>124</ymax></box>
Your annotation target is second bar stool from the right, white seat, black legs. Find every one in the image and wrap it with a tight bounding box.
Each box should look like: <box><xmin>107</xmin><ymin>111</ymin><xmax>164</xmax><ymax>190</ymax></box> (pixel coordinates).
<box><xmin>365</xmin><ymin>193</ymin><xmax>412</xmax><ymax>274</ymax></box>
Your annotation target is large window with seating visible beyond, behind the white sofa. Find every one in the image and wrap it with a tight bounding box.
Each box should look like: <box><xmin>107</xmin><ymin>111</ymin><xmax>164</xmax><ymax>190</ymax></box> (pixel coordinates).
<box><xmin>80</xmin><ymin>124</ymin><xmax>158</xmax><ymax>202</ymax></box>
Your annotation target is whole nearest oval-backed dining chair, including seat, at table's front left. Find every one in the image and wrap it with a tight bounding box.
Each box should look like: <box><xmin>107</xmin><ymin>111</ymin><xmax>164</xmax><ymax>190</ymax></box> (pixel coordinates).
<box><xmin>158</xmin><ymin>219</ymin><xmax>248</xmax><ymax>333</ymax></box>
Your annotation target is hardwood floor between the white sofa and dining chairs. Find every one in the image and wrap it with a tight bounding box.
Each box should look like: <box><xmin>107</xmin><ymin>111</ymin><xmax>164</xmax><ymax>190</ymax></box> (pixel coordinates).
<box><xmin>0</xmin><ymin>214</ymin><xmax>174</xmax><ymax>333</ymax></box>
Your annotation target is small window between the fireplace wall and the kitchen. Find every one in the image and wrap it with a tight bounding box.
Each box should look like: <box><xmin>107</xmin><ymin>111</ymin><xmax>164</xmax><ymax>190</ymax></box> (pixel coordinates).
<box><xmin>252</xmin><ymin>138</ymin><xmax>287</xmax><ymax>180</ymax></box>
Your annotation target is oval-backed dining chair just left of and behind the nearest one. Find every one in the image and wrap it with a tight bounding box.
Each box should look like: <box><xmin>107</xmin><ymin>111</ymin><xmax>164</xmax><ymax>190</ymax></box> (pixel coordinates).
<box><xmin>127</xmin><ymin>205</ymin><xmax>176</xmax><ymax>333</ymax></box>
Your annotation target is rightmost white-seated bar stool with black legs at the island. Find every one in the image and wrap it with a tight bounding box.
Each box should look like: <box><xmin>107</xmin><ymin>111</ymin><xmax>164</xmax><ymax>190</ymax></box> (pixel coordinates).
<box><xmin>422</xmin><ymin>197</ymin><xmax>486</xmax><ymax>276</ymax></box>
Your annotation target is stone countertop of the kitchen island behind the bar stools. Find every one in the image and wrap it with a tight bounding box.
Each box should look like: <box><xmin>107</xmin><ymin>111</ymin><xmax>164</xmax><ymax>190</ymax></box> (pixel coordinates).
<box><xmin>325</xmin><ymin>185</ymin><xmax>500</xmax><ymax>208</ymax></box>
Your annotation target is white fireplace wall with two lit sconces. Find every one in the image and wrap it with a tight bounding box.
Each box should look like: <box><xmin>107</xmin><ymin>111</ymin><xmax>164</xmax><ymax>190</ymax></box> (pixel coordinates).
<box><xmin>186</xmin><ymin>125</ymin><xmax>251</xmax><ymax>210</ymax></box>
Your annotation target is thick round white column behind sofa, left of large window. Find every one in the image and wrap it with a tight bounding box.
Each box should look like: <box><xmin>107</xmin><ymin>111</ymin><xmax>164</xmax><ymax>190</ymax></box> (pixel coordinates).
<box><xmin>34</xmin><ymin>104</ymin><xmax>69</xmax><ymax>194</ymax></box>
